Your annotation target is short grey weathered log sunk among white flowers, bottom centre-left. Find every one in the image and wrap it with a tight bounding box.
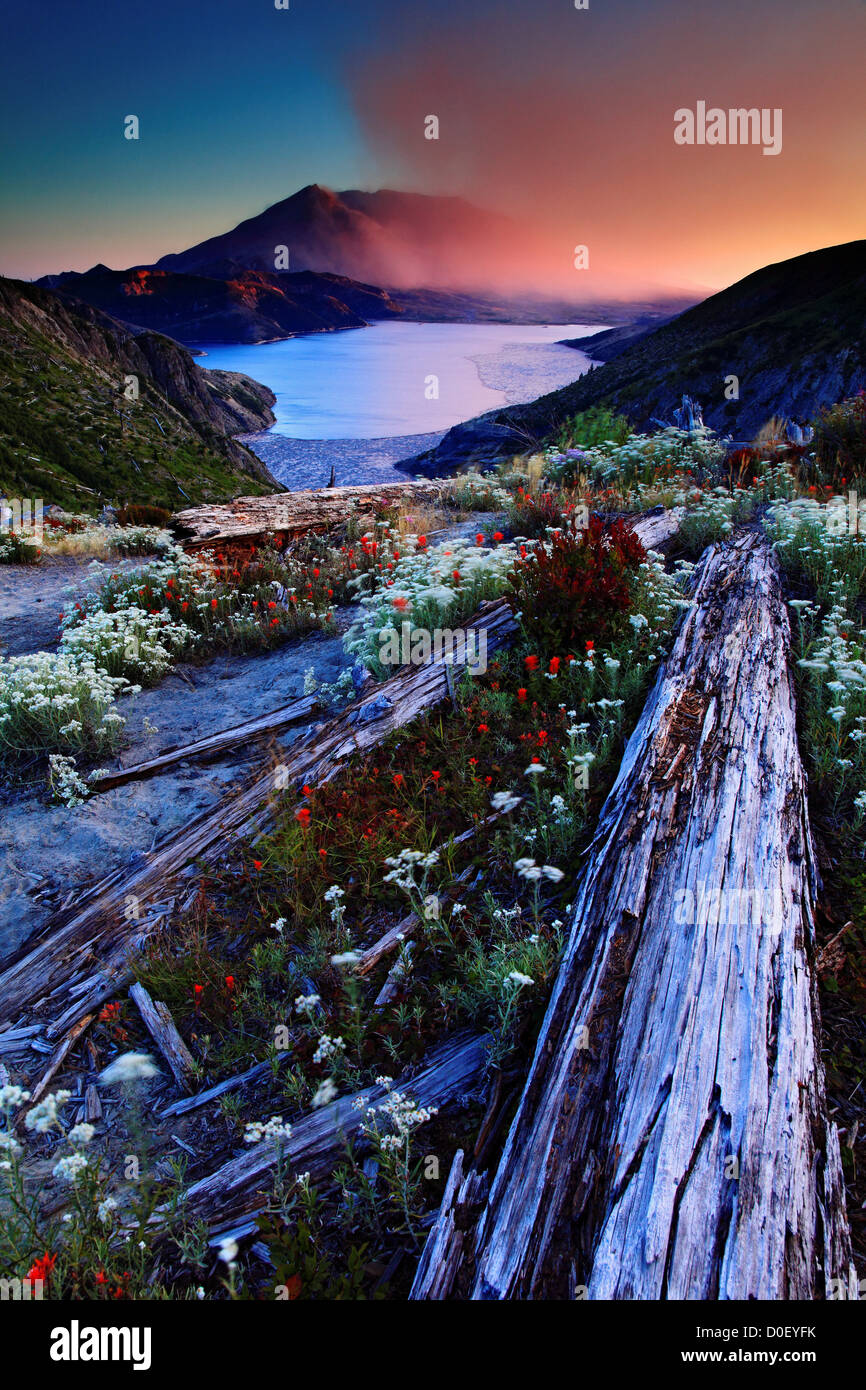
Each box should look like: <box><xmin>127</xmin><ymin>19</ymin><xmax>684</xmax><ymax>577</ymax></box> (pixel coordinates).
<box><xmin>175</xmin><ymin>1033</ymin><xmax>488</xmax><ymax>1225</ymax></box>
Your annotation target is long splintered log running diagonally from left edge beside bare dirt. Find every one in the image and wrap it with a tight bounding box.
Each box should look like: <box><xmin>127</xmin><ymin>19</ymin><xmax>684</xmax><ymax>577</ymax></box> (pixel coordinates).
<box><xmin>0</xmin><ymin>602</ymin><xmax>516</xmax><ymax>1036</ymax></box>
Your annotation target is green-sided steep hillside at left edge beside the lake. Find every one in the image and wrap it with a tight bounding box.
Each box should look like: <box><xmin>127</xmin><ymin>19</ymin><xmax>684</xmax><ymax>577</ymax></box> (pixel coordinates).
<box><xmin>0</xmin><ymin>278</ymin><xmax>281</xmax><ymax>512</ymax></box>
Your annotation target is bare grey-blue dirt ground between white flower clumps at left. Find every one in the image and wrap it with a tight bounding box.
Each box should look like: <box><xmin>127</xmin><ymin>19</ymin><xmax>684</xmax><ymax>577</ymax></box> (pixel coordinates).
<box><xmin>0</xmin><ymin>514</ymin><xmax>505</xmax><ymax>962</ymax></box>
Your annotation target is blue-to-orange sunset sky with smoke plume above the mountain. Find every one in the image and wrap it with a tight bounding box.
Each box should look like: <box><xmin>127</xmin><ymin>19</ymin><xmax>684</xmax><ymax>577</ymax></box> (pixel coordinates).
<box><xmin>0</xmin><ymin>0</ymin><xmax>866</xmax><ymax>297</ymax></box>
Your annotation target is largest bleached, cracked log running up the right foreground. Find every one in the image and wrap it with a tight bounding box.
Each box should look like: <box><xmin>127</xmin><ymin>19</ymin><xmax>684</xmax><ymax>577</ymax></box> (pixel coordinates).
<box><xmin>458</xmin><ymin>534</ymin><xmax>852</xmax><ymax>1300</ymax></box>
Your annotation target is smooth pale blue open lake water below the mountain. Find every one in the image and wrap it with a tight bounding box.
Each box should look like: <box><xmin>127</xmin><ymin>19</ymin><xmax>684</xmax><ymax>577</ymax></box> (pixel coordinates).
<box><xmin>197</xmin><ymin>322</ymin><xmax>601</xmax><ymax>439</ymax></box>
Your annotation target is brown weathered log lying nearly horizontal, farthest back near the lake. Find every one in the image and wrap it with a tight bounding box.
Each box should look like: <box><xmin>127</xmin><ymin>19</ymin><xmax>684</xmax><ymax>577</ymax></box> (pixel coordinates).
<box><xmin>171</xmin><ymin>482</ymin><xmax>445</xmax><ymax>549</ymax></box>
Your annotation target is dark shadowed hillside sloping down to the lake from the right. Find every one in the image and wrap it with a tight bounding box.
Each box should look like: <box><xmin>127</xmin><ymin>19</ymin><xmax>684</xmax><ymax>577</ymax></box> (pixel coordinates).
<box><xmin>405</xmin><ymin>240</ymin><xmax>866</xmax><ymax>473</ymax></box>
